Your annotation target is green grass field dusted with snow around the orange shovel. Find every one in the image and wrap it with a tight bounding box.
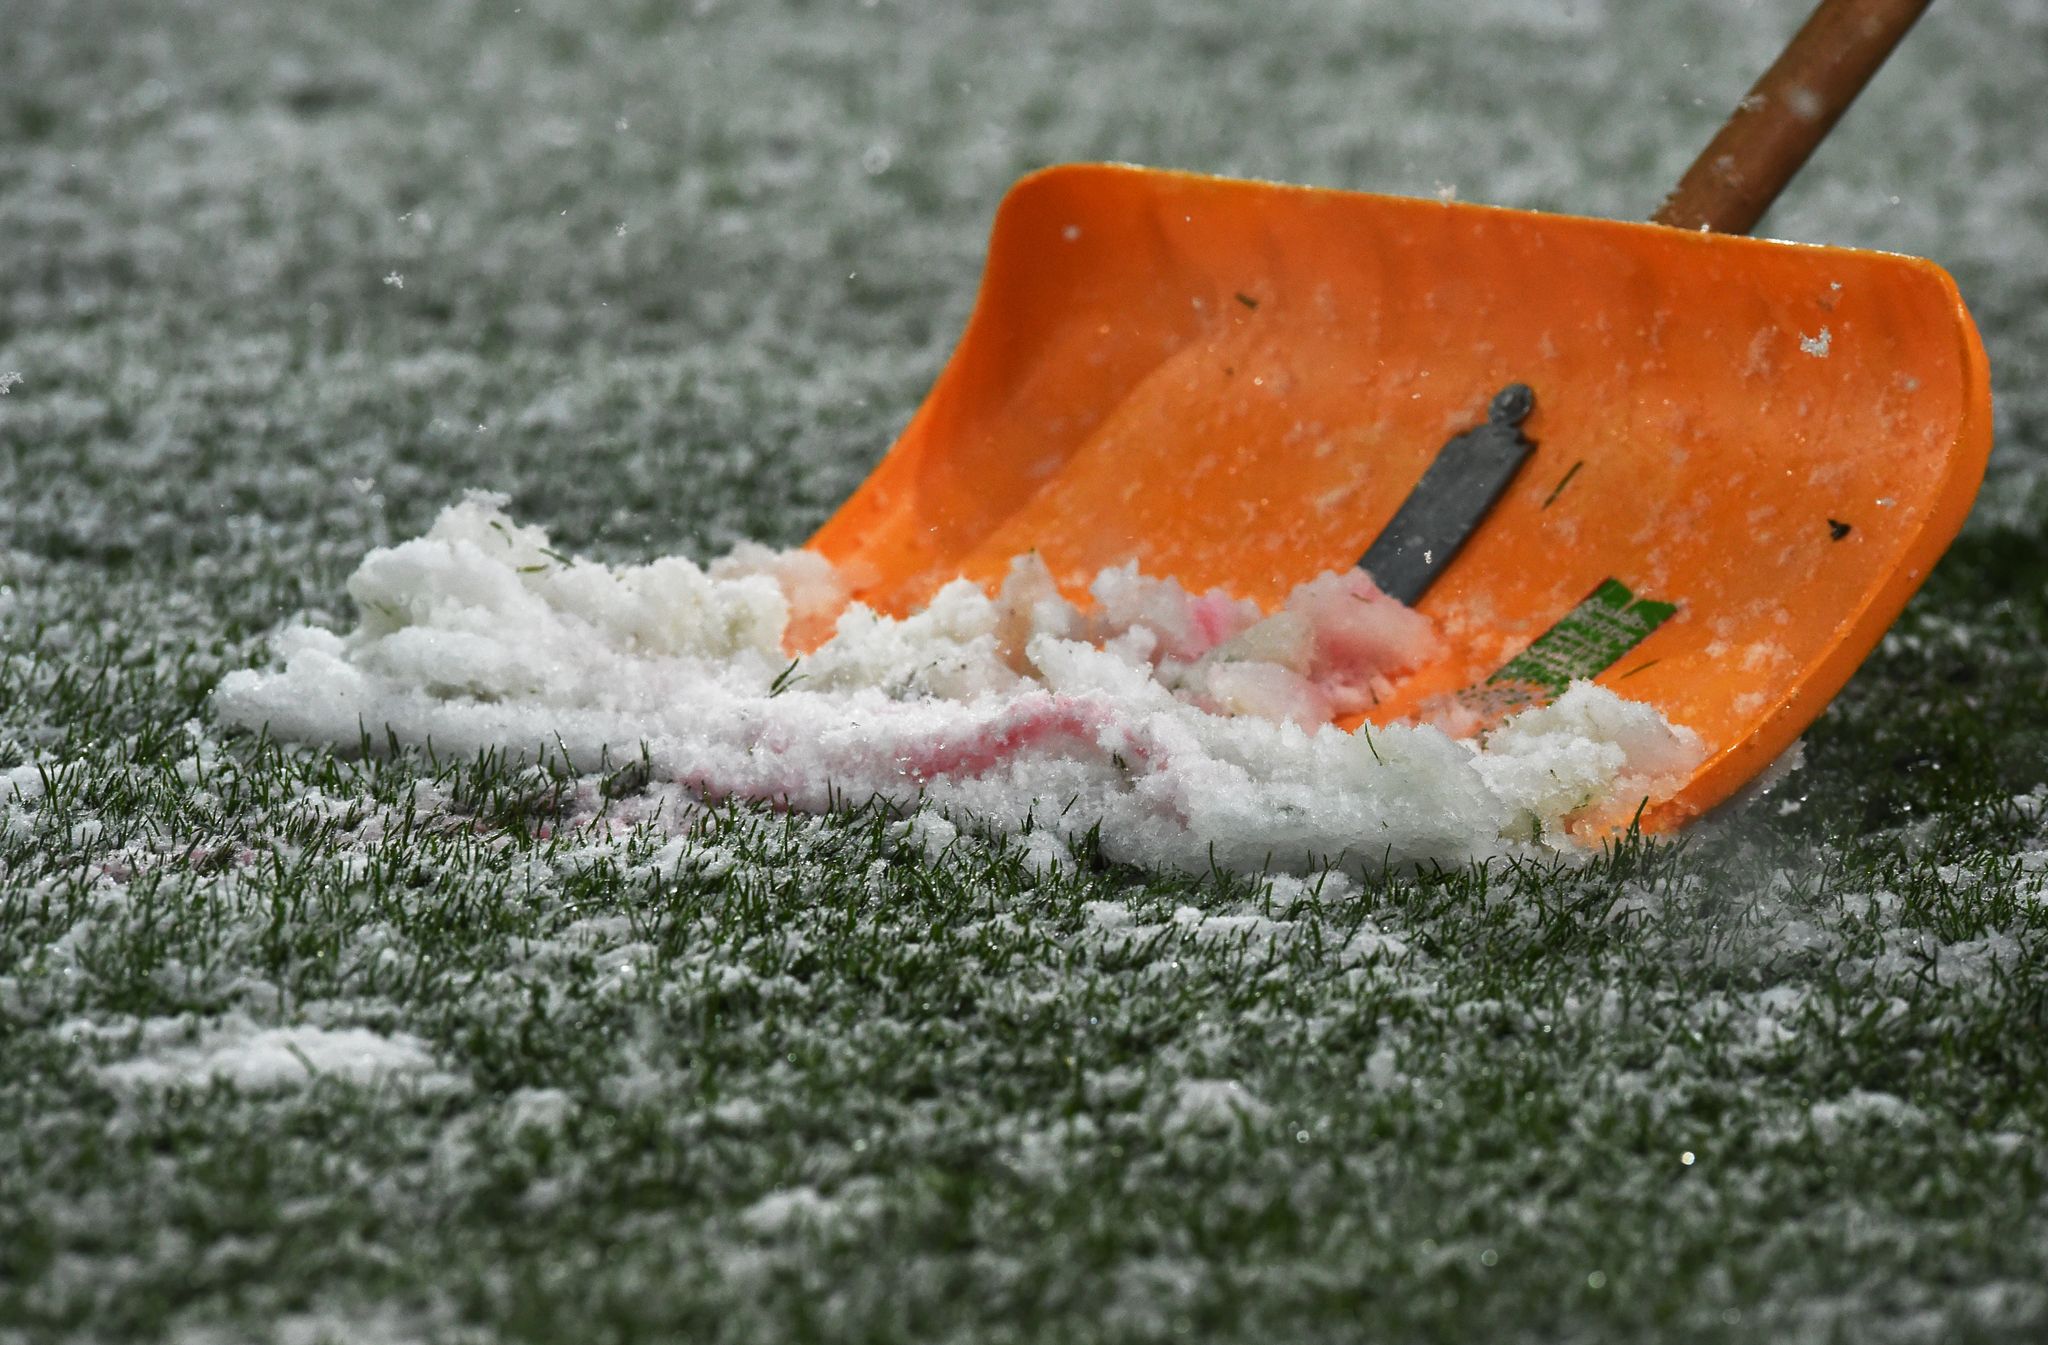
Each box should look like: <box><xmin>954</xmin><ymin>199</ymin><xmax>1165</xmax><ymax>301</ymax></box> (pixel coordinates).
<box><xmin>0</xmin><ymin>0</ymin><xmax>2048</xmax><ymax>1345</ymax></box>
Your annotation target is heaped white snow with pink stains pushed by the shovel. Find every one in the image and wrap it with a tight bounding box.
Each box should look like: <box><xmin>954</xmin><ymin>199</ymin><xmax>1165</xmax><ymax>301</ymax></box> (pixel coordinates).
<box><xmin>215</xmin><ymin>495</ymin><xmax>1700</xmax><ymax>870</ymax></box>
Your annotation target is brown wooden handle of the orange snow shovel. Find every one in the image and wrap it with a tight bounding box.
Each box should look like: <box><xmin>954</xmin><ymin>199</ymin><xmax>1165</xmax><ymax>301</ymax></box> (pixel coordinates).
<box><xmin>1651</xmin><ymin>0</ymin><xmax>1933</xmax><ymax>233</ymax></box>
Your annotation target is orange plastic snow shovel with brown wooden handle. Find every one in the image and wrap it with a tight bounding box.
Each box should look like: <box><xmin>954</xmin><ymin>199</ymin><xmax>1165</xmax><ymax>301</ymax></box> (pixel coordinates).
<box><xmin>811</xmin><ymin>0</ymin><xmax>1991</xmax><ymax>829</ymax></box>
